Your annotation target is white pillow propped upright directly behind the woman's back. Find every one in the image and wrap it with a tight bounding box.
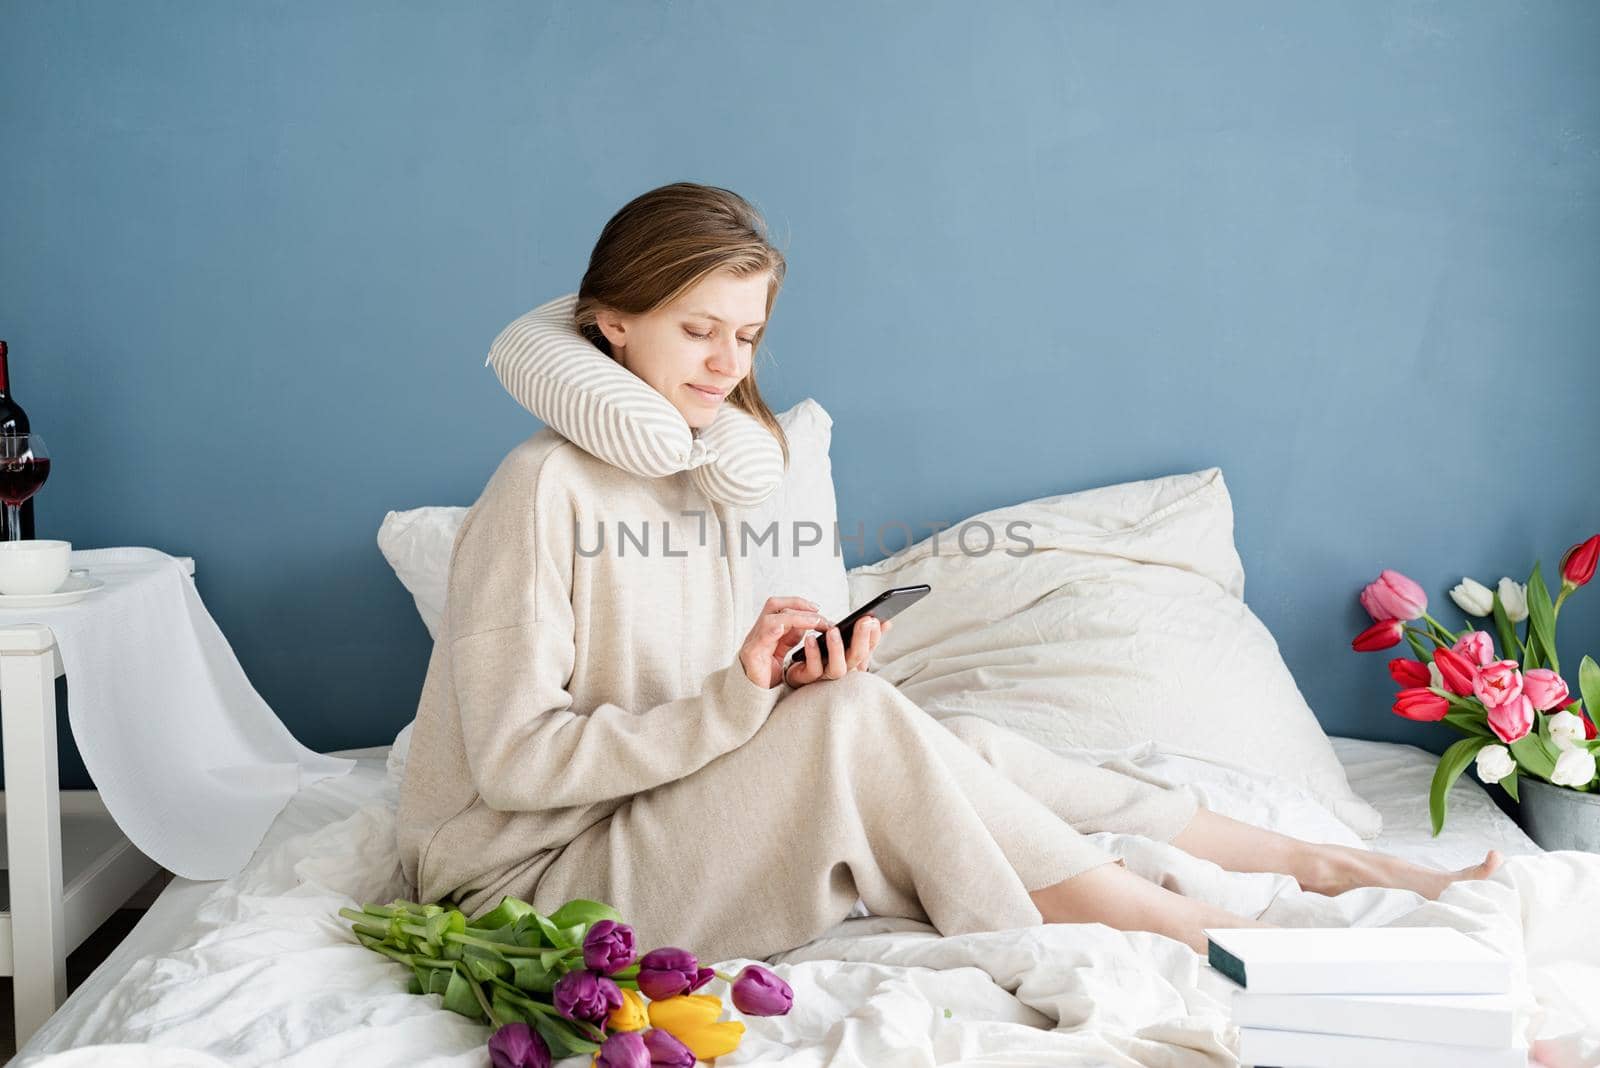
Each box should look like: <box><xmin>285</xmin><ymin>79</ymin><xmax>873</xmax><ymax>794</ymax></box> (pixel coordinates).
<box><xmin>378</xmin><ymin>399</ymin><xmax>850</xmax><ymax>783</ymax></box>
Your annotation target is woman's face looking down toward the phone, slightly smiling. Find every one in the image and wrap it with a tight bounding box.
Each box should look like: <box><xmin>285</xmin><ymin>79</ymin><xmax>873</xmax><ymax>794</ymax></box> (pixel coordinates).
<box><xmin>597</xmin><ymin>272</ymin><xmax>771</xmax><ymax>428</ymax></box>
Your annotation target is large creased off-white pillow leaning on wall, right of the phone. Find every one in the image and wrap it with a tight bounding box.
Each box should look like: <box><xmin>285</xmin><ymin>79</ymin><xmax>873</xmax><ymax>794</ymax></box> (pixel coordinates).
<box><xmin>848</xmin><ymin>468</ymin><xmax>1382</xmax><ymax>838</ymax></box>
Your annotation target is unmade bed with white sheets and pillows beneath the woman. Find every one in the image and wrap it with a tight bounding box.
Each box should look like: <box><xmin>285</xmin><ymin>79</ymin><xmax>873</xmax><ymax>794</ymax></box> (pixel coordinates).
<box><xmin>16</xmin><ymin>412</ymin><xmax>1600</xmax><ymax>1068</ymax></box>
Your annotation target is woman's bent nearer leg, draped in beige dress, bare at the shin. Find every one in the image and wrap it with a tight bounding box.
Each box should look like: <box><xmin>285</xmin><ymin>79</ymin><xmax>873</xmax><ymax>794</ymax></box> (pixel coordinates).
<box><xmin>537</xmin><ymin>671</ymin><xmax>1248</xmax><ymax>959</ymax></box>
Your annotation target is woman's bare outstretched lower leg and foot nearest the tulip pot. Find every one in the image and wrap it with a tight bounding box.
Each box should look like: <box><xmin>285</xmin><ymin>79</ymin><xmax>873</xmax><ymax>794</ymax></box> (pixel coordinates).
<box><xmin>1173</xmin><ymin>809</ymin><xmax>1501</xmax><ymax>899</ymax></box>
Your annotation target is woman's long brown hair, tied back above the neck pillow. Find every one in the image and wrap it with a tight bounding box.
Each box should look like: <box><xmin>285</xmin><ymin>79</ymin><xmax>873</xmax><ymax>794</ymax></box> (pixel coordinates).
<box><xmin>573</xmin><ymin>182</ymin><xmax>789</xmax><ymax>468</ymax></box>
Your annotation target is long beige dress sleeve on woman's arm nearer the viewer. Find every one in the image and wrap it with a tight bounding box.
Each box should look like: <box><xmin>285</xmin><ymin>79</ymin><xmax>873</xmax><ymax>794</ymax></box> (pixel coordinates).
<box><xmin>445</xmin><ymin>434</ymin><xmax>789</xmax><ymax>811</ymax></box>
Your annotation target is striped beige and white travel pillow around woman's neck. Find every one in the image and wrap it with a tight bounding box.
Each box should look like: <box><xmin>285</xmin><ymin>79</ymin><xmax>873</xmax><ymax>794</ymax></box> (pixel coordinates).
<box><xmin>485</xmin><ymin>293</ymin><xmax>784</xmax><ymax>508</ymax></box>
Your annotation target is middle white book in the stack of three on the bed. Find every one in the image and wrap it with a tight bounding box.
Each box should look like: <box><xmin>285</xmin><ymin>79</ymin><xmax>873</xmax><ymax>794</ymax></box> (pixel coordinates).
<box><xmin>1229</xmin><ymin>983</ymin><xmax>1517</xmax><ymax>1049</ymax></box>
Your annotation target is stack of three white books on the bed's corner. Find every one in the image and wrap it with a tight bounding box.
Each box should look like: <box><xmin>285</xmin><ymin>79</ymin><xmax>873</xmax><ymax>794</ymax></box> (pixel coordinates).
<box><xmin>1206</xmin><ymin>927</ymin><xmax>1528</xmax><ymax>1068</ymax></box>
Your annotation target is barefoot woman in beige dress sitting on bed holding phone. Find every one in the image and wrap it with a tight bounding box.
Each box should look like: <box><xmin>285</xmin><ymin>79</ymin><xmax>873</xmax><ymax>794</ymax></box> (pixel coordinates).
<box><xmin>400</xmin><ymin>182</ymin><xmax>1499</xmax><ymax>961</ymax></box>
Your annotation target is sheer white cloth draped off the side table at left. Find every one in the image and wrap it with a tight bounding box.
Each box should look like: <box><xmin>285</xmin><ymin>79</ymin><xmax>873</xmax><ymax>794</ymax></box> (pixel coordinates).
<box><xmin>0</xmin><ymin>548</ymin><xmax>355</xmax><ymax>879</ymax></box>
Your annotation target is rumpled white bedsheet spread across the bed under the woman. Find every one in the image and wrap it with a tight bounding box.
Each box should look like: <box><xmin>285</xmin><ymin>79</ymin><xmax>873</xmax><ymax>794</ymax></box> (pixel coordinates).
<box><xmin>13</xmin><ymin>739</ymin><xmax>1600</xmax><ymax>1068</ymax></box>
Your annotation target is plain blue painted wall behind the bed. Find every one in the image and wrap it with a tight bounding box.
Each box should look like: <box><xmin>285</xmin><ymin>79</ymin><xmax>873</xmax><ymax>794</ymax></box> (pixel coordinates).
<box><xmin>0</xmin><ymin>0</ymin><xmax>1600</xmax><ymax>785</ymax></box>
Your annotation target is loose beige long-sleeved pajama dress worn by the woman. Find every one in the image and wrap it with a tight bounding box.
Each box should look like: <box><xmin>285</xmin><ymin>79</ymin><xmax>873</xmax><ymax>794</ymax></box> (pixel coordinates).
<box><xmin>398</xmin><ymin>428</ymin><xmax>1195</xmax><ymax>961</ymax></box>
